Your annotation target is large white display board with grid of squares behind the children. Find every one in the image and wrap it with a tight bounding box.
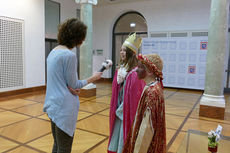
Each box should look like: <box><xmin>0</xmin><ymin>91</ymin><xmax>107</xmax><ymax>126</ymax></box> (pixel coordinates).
<box><xmin>142</xmin><ymin>37</ymin><xmax>208</xmax><ymax>89</ymax></box>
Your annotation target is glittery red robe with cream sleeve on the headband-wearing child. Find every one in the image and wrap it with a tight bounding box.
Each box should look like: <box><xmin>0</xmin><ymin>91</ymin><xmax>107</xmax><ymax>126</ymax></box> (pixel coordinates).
<box><xmin>123</xmin><ymin>81</ymin><xmax>166</xmax><ymax>153</ymax></box>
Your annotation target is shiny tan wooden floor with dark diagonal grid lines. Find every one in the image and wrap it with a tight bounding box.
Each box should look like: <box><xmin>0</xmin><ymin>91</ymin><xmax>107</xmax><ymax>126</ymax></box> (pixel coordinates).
<box><xmin>0</xmin><ymin>83</ymin><xmax>230</xmax><ymax>153</ymax></box>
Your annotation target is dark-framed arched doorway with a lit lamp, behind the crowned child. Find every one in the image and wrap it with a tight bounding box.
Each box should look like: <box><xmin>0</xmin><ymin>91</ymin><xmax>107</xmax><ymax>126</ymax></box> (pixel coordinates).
<box><xmin>112</xmin><ymin>11</ymin><xmax>148</xmax><ymax>77</ymax></box>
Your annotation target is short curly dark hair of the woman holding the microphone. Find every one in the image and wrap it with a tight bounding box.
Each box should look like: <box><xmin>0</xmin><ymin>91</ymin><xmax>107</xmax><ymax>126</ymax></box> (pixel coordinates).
<box><xmin>58</xmin><ymin>18</ymin><xmax>87</xmax><ymax>49</ymax></box>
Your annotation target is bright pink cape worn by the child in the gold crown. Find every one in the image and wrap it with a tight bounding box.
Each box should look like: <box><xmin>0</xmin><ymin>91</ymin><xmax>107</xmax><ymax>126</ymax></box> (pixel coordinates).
<box><xmin>108</xmin><ymin>67</ymin><xmax>145</xmax><ymax>153</ymax></box>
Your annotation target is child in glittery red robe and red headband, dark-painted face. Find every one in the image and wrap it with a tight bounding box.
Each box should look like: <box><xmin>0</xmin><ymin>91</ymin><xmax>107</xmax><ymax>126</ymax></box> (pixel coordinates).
<box><xmin>123</xmin><ymin>54</ymin><xmax>166</xmax><ymax>153</ymax></box>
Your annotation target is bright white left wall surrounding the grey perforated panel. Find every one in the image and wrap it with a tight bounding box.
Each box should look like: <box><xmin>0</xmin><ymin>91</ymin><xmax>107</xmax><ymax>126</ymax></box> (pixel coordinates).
<box><xmin>0</xmin><ymin>0</ymin><xmax>45</xmax><ymax>88</ymax></box>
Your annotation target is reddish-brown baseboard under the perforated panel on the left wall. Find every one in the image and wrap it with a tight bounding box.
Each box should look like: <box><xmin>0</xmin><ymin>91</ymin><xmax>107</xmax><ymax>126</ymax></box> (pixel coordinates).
<box><xmin>0</xmin><ymin>86</ymin><xmax>46</xmax><ymax>98</ymax></box>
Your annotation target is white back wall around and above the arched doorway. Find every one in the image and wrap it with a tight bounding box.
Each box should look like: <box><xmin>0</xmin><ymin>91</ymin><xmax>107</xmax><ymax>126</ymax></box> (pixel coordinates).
<box><xmin>93</xmin><ymin>0</ymin><xmax>211</xmax><ymax>78</ymax></box>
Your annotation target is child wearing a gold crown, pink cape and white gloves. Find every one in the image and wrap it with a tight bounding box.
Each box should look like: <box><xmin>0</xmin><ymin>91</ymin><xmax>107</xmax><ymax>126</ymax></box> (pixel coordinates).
<box><xmin>108</xmin><ymin>33</ymin><xmax>145</xmax><ymax>153</ymax></box>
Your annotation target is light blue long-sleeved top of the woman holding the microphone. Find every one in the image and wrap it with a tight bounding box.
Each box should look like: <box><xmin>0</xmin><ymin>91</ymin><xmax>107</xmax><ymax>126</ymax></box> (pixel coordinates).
<box><xmin>43</xmin><ymin>49</ymin><xmax>87</xmax><ymax>136</ymax></box>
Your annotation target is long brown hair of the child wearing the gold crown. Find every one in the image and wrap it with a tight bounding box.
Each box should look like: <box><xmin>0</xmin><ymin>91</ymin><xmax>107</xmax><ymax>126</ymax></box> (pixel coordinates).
<box><xmin>120</xmin><ymin>47</ymin><xmax>138</xmax><ymax>72</ymax></box>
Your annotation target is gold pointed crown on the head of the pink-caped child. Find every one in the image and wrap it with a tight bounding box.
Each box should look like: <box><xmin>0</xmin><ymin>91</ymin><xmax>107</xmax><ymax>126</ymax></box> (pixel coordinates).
<box><xmin>123</xmin><ymin>33</ymin><xmax>142</xmax><ymax>53</ymax></box>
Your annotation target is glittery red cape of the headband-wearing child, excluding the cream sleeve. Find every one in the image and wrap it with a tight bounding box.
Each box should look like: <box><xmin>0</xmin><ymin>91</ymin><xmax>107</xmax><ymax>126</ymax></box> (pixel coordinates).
<box><xmin>123</xmin><ymin>82</ymin><xmax>166</xmax><ymax>153</ymax></box>
